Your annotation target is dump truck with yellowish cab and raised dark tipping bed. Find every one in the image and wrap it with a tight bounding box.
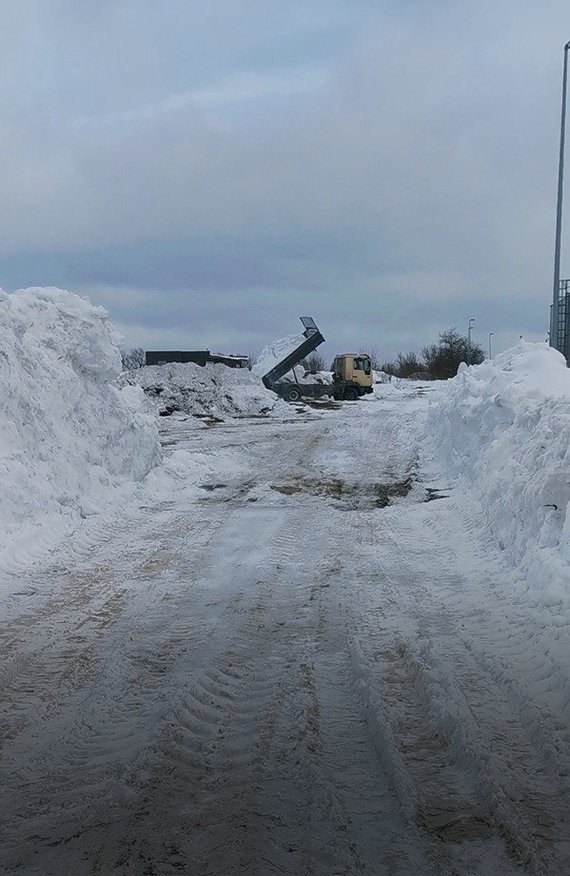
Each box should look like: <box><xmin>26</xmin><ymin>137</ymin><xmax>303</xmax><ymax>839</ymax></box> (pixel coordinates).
<box><xmin>261</xmin><ymin>316</ymin><xmax>372</xmax><ymax>402</ymax></box>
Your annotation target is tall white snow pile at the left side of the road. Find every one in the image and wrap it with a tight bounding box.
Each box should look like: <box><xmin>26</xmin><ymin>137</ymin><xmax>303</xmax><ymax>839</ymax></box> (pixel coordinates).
<box><xmin>0</xmin><ymin>288</ymin><xmax>159</xmax><ymax>566</ymax></box>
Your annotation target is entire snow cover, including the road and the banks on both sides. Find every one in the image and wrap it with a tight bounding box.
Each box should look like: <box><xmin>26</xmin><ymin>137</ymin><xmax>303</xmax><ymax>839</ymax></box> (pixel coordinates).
<box><xmin>0</xmin><ymin>289</ymin><xmax>570</xmax><ymax>876</ymax></box>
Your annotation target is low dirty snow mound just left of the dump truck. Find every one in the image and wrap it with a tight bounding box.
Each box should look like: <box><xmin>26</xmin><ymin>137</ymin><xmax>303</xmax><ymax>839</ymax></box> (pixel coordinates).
<box><xmin>119</xmin><ymin>362</ymin><xmax>289</xmax><ymax>419</ymax></box>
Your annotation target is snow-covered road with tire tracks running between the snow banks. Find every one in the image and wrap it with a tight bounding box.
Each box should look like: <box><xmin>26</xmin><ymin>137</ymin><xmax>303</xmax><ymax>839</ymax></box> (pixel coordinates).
<box><xmin>0</xmin><ymin>392</ymin><xmax>570</xmax><ymax>876</ymax></box>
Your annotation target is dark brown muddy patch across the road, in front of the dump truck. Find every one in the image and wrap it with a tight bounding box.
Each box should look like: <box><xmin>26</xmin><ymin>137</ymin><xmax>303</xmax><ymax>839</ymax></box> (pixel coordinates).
<box><xmin>270</xmin><ymin>477</ymin><xmax>413</xmax><ymax>511</ymax></box>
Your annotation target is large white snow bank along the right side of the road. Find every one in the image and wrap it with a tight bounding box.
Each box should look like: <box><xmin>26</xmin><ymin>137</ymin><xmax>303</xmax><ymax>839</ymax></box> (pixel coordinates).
<box><xmin>427</xmin><ymin>341</ymin><xmax>570</xmax><ymax>604</ymax></box>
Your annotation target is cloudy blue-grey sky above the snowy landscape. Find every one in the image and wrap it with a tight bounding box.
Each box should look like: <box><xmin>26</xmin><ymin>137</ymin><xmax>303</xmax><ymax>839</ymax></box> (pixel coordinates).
<box><xmin>0</xmin><ymin>0</ymin><xmax>570</xmax><ymax>360</ymax></box>
